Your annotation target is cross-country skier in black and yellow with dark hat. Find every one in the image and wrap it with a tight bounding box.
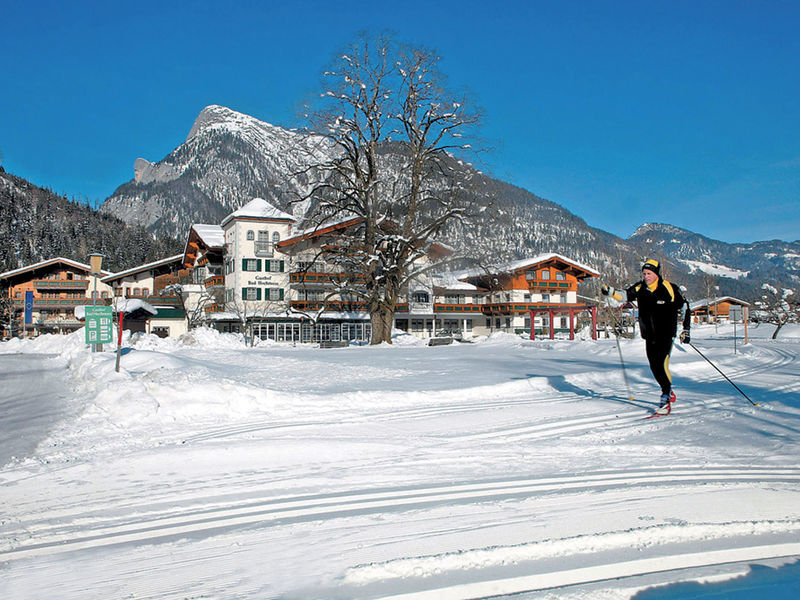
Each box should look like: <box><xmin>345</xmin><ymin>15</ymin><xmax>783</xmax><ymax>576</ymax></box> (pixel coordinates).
<box><xmin>601</xmin><ymin>259</ymin><xmax>691</xmax><ymax>414</ymax></box>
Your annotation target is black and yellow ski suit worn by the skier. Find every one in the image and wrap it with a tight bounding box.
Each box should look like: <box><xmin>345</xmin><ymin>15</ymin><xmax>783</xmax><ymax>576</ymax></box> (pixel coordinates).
<box><xmin>625</xmin><ymin>277</ymin><xmax>691</xmax><ymax>394</ymax></box>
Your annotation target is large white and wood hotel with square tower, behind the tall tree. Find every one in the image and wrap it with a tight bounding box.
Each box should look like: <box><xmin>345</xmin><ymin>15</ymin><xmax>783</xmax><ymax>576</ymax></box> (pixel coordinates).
<box><xmin>175</xmin><ymin>198</ymin><xmax>598</xmax><ymax>342</ymax></box>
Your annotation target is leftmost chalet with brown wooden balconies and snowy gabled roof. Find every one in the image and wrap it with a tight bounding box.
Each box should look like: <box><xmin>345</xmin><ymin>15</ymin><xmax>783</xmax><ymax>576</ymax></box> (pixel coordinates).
<box><xmin>0</xmin><ymin>258</ymin><xmax>112</xmax><ymax>339</ymax></box>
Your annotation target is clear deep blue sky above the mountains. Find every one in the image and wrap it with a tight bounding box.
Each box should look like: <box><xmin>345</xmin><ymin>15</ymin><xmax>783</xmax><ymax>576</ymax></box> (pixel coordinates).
<box><xmin>0</xmin><ymin>0</ymin><xmax>800</xmax><ymax>242</ymax></box>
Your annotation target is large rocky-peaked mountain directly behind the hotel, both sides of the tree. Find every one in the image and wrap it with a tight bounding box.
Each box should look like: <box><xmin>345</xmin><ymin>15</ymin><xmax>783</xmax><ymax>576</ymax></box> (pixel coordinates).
<box><xmin>100</xmin><ymin>106</ymin><xmax>639</xmax><ymax>282</ymax></box>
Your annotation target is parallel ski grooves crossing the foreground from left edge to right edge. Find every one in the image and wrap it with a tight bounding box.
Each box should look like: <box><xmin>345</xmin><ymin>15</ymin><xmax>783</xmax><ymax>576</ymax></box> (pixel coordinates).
<box><xmin>6</xmin><ymin>467</ymin><xmax>800</xmax><ymax>563</ymax></box>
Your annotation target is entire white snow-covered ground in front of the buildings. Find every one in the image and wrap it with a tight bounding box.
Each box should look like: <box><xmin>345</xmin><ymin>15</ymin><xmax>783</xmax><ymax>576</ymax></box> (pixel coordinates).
<box><xmin>0</xmin><ymin>326</ymin><xmax>800</xmax><ymax>600</ymax></box>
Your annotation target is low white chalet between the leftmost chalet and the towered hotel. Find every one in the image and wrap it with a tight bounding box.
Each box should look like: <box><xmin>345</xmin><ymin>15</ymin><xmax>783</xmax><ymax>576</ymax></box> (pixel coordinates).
<box><xmin>101</xmin><ymin>254</ymin><xmax>189</xmax><ymax>337</ymax></box>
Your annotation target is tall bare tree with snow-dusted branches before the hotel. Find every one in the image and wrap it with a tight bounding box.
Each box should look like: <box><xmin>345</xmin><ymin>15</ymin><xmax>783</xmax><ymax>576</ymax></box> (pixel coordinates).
<box><xmin>301</xmin><ymin>36</ymin><xmax>479</xmax><ymax>344</ymax></box>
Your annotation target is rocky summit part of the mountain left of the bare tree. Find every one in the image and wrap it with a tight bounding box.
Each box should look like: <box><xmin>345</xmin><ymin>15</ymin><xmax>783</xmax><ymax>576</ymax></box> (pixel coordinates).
<box><xmin>100</xmin><ymin>106</ymin><xmax>332</xmax><ymax>235</ymax></box>
